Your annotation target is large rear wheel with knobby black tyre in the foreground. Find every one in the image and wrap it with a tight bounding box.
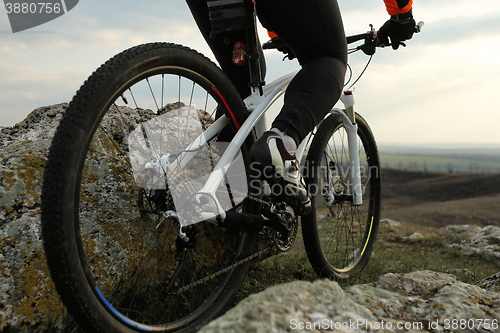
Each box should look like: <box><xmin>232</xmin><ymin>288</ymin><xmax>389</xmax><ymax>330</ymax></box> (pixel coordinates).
<box><xmin>42</xmin><ymin>43</ymin><xmax>256</xmax><ymax>333</ymax></box>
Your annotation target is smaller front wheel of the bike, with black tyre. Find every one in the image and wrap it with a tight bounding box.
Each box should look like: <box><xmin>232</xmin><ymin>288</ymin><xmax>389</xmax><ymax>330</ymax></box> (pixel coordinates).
<box><xmin>302</xmin><ymin>114</ymin><xmax>381</xmax><ymax>278</ymax></box>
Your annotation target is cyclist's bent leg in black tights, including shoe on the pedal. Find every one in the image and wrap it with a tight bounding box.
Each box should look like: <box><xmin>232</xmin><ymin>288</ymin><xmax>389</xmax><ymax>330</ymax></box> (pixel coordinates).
<box><xmin>250</xmin><ymin>0</ymin><xmax>347</xmax><ymax>215</ymax></box>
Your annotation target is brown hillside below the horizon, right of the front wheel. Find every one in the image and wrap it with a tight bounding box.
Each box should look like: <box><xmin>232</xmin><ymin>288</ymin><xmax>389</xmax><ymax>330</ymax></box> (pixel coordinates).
<box><xmin>382</xmin><ymin>169</ymin><xmax>500</xmax><ymax>227</ymax></box>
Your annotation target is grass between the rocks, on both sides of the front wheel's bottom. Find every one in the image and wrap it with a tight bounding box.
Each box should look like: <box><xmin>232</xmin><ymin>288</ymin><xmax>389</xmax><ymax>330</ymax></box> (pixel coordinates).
<box><xmin>234</xmin><ymin>220</ymin><xmax>500</xmax><ymax>304</ymax></box>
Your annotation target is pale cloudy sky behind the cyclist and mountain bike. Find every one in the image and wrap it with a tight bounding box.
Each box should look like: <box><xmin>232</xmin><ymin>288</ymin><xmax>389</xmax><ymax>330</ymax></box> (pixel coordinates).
<box><xmin>0</xmin><ymin>0</ymin><xmax>500</xmax><ymax>148</ymax></box>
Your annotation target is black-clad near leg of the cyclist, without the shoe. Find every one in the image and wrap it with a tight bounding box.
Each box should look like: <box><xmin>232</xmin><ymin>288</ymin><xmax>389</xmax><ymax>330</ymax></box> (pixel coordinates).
<box><xmin>257</xmin><ymin>0</ymin><xmax>347</xmax><ymax>144</ymax></box>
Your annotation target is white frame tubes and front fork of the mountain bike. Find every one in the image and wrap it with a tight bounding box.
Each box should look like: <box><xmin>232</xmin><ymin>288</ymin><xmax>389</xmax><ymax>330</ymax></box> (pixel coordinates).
<box><xmin>176</xmin><ymin>72</ymin><xmax>363</xmax><ymax>220</ymax></box>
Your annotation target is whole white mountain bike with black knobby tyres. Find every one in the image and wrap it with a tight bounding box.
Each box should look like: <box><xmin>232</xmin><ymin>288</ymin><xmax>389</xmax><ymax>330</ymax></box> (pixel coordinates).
<box><xmin>42</xmin><ymin>1</ymin><xmax>422</xmax><ymax>333</ymax></box>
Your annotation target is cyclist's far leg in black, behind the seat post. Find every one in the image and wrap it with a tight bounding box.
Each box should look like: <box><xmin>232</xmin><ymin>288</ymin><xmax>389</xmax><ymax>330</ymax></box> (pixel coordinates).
<box><xmin>186</xmin><ymin>0</ymin><xmax>266</xmax><ymax>98</ymax></box>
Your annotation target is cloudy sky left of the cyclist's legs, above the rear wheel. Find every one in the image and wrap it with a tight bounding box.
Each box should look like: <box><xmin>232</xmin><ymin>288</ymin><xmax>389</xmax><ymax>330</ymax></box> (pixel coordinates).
<box><xmin>0</xmin><ymin>0</ymin><xmax>210</xmax><ymax>126</ymax></box>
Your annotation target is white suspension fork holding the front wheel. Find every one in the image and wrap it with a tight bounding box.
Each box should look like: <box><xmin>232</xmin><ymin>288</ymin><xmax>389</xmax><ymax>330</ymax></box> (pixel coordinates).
<box><xmin>335</xmin><ymin>91</ymin><xmax>363</xmax><ymax>206</ymax></box>
